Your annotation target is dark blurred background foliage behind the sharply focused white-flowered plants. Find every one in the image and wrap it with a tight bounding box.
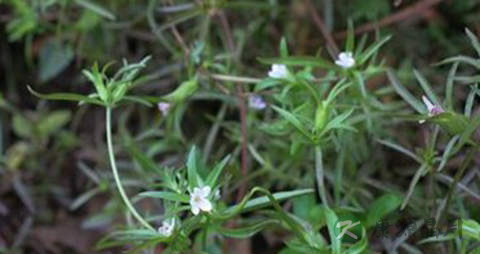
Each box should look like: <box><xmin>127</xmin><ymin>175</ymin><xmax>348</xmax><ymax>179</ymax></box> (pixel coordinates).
<box><xmin>0</xmin><ymin>0</ymin><xmax>480</xmax><ymax>253</ymax></box>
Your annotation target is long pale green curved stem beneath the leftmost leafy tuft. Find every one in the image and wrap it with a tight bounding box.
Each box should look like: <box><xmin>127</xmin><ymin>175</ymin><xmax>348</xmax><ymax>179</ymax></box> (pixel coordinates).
<box><xmin>106</xmin><ymin>107</ymin><xmax>155</xmax><ymax>230</ymax></box>
